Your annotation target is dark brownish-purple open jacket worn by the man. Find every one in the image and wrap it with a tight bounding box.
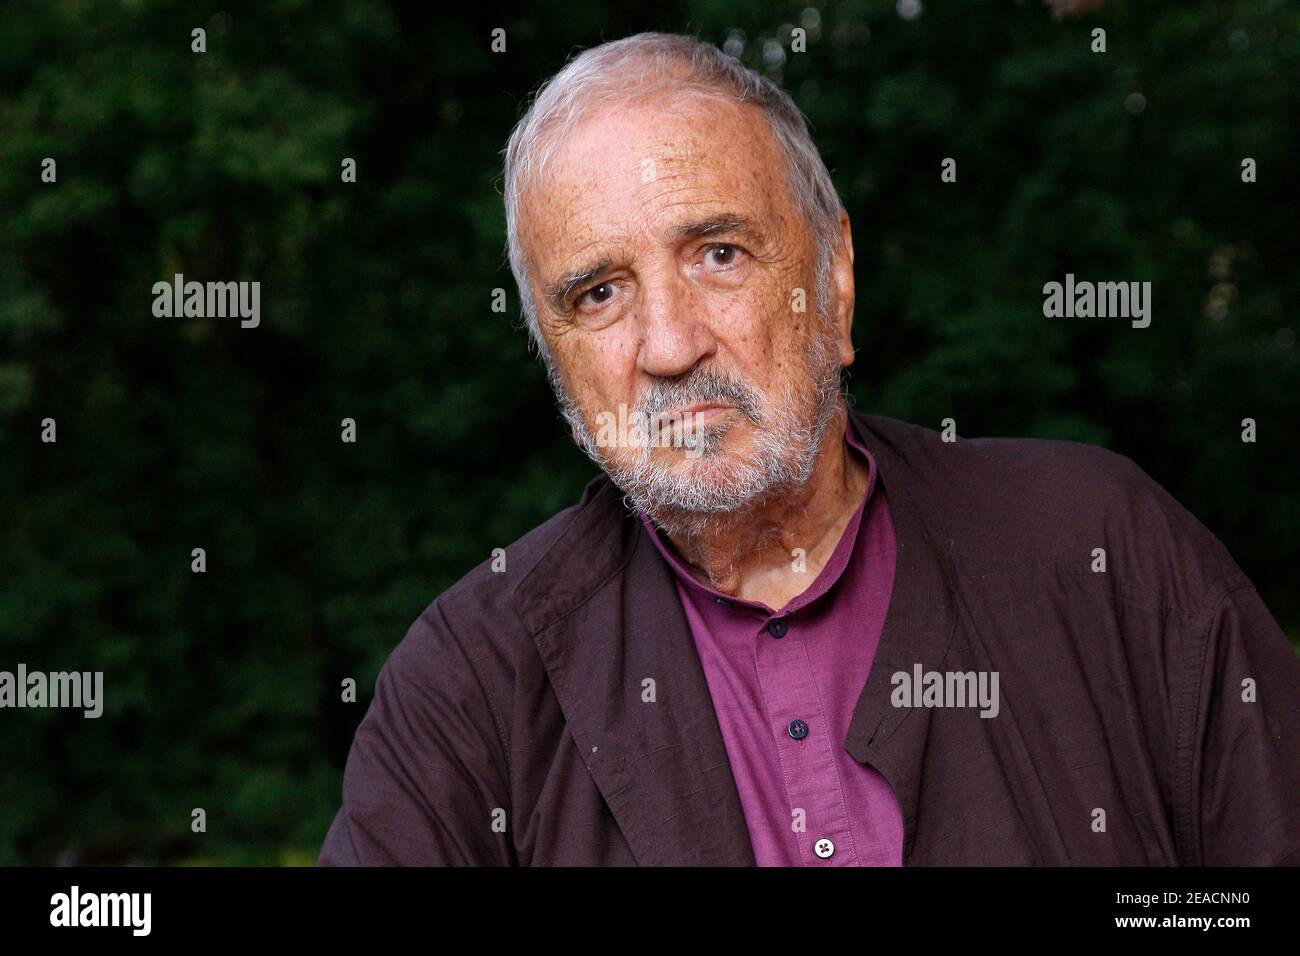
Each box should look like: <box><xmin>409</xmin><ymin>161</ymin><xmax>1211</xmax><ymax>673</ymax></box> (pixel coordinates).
<box><xmin>320</xmin><ymin>412</ymin><xmax>1300</xmax><ymax>866</ymax></box>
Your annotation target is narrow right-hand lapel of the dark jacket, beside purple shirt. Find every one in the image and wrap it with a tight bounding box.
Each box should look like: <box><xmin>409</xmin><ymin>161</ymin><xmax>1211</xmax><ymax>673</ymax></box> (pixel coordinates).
<box><xmin>845</xmin><ymin>411</ymin><xmax>957</xmax><ymax>864</ymax></box>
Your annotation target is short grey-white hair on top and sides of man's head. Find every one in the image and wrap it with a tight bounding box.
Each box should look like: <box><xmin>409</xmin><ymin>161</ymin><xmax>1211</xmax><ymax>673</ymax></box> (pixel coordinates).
<box><xmin>503</xmin><ymin>33</ymin><xmax>844</xmax><ymax>369</ymax></box>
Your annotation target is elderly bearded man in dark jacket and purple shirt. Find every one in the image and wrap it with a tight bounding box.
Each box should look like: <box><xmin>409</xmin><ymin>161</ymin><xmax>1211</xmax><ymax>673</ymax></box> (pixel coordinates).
<box><xmin>320</xmin><ymin>34</ymin><xmax>1300</xmax><ymax>866</ymax></box>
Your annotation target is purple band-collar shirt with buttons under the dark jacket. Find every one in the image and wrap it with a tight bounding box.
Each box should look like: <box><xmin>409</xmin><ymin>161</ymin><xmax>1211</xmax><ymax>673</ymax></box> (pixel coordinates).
<box><xmin>641</xmin><ymin>427</ymin><xmax>904</xmax><ymax>866</ymax></box>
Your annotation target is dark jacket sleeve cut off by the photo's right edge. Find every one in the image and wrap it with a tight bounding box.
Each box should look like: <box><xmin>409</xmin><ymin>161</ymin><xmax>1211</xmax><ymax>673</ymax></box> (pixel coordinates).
<box><xmin>1179</xmin><ymin>576</ymin><xmax>1300</xmax><ymax>866</ymax></box>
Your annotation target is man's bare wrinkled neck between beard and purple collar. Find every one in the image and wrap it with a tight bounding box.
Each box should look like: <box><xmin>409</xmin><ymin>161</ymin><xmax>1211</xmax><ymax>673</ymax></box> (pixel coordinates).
<box><xmin>655</xmin><ymin>407</ymin><xmax>868</xmax><ymax>610</ymax></box>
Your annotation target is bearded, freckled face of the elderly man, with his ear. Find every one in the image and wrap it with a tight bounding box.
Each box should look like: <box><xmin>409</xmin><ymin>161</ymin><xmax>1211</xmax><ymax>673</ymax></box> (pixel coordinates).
<box><xmin>520</xmin><ymin>99</ymin><xmax>853</xmax><ymax>528</ymax></box>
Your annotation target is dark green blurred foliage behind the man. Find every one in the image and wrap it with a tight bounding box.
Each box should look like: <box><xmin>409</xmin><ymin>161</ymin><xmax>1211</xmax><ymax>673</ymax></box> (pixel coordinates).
<box><xmin>0</xmin><ymin>0</ymin><xmax>1300</xmax><ymax>864</ymax></box>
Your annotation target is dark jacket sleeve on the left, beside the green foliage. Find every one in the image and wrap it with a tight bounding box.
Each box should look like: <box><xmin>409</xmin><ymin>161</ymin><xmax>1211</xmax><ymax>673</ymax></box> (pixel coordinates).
<box><xmin>317</xmin><ymin>602</ymin><xmax>515</xmax><ymax>866</ymax></box>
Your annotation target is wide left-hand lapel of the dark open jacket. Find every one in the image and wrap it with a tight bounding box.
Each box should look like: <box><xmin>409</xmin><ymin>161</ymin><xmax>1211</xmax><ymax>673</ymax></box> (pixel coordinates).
<box><xmin>515</xmin><ymin>476</ymin><xmax>755</xmax><ymax>866</ymax></box>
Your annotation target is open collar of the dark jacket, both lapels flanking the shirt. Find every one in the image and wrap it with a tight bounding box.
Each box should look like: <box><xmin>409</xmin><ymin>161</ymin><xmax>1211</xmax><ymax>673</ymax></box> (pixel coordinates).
<box><xmin>515</xmin><ymin>410</ymin><xmax>954</xmax><ymax>866</ymax></box>
